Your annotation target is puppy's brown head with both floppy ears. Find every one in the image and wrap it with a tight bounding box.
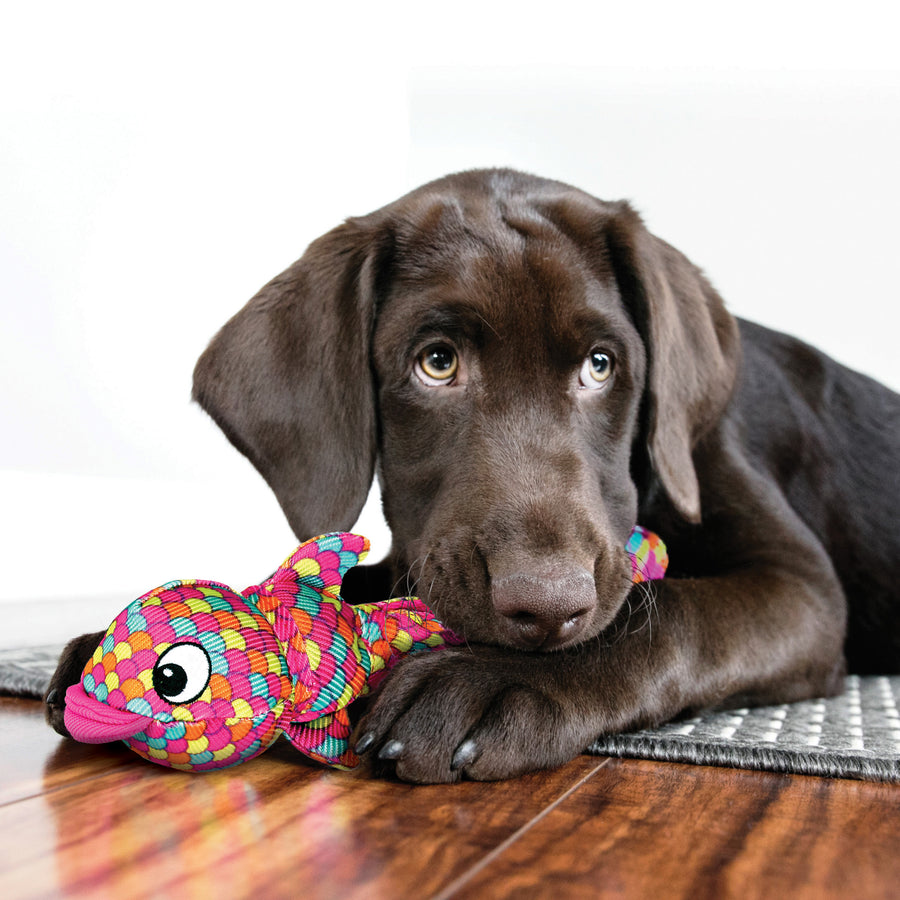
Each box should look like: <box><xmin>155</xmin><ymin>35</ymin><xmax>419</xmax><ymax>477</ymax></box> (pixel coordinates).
<box><xmin>194</xmin><ymin>170</ymin><xmax>738</xmax><ymax>649</ymax></box>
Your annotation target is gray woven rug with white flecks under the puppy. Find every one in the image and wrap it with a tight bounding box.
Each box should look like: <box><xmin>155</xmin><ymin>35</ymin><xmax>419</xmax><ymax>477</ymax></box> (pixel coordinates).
<box><xmin>0</xmin><ymin>645</ymin><xmax>900</xmax><ymax>782</ymax></box>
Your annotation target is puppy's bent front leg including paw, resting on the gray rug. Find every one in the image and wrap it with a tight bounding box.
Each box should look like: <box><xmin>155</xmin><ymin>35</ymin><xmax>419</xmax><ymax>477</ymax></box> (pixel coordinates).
<box><xmin>356</xmin><ymin>450</ymin><xmax>846</xmax><ymax>782</ymax></box>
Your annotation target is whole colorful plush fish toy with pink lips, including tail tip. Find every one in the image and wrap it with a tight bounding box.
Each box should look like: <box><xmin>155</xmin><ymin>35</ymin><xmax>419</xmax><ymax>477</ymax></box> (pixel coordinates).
<box><xmin>65</xmin><ymin>527</ymin><xmax>668</xmax><ymax>772</ymax></box>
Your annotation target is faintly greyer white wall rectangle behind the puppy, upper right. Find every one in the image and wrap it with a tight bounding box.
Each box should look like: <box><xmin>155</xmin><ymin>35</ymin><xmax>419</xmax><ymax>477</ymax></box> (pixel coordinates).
<box><xmin>410</xmin><ymin>67</ymin><xmax>900</xmax><ymax>389</ymax></box>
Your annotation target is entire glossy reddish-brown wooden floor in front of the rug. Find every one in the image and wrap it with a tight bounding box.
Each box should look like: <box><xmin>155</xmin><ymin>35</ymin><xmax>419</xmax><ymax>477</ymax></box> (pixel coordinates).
<box><xmin>0</xmin><ymin>698</ymin><xmax>900</xmax><ymax>900</ymax></box>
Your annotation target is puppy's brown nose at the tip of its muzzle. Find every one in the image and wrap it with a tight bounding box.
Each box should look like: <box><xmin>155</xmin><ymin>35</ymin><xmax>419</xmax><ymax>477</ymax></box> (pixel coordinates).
<box><xmin>491</xmin><ymin>566</ymin><xmax>597</xmax><ymax>650</ymax></box>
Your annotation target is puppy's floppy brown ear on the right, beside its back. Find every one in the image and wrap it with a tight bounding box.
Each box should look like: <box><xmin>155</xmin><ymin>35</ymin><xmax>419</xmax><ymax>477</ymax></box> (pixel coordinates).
<box><xmin>606</xmin><ymin>203</ymin><xmax>740</xmax><ymax>522</ymax></box>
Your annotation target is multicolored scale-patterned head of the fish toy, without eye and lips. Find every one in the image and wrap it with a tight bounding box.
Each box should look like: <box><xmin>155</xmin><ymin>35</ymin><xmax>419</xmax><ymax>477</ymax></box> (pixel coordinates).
<box><xmin>82</xmin><ymin>581</ymin><xmax>294</xmax><ymax>771</ymax></box>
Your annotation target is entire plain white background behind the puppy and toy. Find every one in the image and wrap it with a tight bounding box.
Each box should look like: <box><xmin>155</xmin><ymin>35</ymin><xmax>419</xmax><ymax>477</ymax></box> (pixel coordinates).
<box><xmin>0</xmin><ymin>0</ymin><xmax>900</xmax><ymax>628</ymax></box>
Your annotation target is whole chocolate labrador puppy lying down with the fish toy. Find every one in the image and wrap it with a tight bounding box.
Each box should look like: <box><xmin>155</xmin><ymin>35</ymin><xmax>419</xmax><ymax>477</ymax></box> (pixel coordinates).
<box><xmin>44</xmin><ymin>170</ymin><xmax>900</xmax><ymax>782</ymax></box>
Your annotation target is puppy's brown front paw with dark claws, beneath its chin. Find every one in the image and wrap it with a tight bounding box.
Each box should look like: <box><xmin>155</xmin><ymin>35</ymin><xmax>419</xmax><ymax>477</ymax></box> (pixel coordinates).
<box><xmin>355</xmin><ymin>647</ymin><xmax>587</xmax><ymax>783</ymax></box>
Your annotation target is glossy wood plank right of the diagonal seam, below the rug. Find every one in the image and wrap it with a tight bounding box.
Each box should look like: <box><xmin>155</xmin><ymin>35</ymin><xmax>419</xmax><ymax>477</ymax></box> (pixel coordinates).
<box><xmin>454</xmin><ymin>761</ymin><xmax>900</xmax><ymax>900</ymax></box>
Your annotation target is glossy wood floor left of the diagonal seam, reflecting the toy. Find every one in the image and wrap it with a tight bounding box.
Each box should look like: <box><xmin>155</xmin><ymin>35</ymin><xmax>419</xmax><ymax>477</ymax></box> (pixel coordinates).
<box><xmin>0</xmin><ymin>696</ymin><xmax>600</xmax><ymax>898</ymax></box>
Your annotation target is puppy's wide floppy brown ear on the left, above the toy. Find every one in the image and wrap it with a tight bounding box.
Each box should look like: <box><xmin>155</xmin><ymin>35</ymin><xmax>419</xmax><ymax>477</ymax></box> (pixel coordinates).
<box><xmin>193</xmin><ymin>220</ymin><xmax>379</xmax><ymax>540</ymax></box>
